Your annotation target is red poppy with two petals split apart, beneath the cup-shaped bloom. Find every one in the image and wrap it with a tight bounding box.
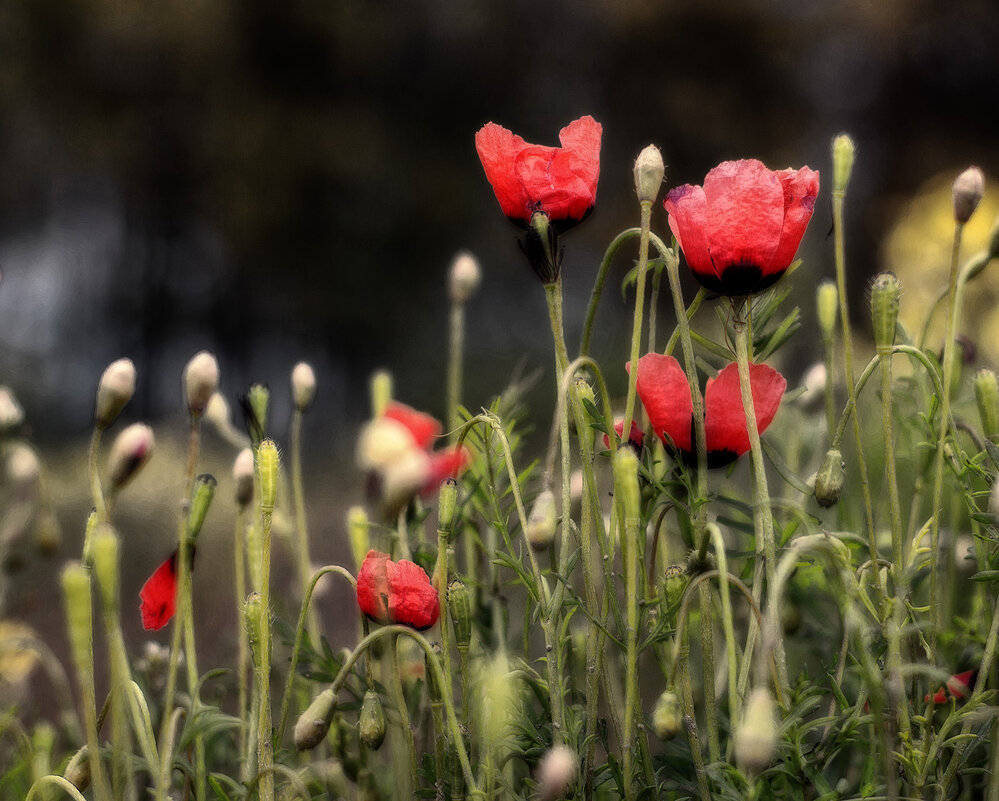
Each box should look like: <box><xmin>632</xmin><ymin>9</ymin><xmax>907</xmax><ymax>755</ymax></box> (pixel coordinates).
<box><xmin>629</xmin><ymin>353</ymin><xmax>787</xmax><ymax>467</ymax></box>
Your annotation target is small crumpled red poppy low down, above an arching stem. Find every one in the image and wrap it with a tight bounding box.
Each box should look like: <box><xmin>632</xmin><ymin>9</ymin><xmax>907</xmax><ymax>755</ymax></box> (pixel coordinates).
<box><xmin>357</xmin><ymin>551</ymin><xmax>441</xmax><ymax>631</ymax></box>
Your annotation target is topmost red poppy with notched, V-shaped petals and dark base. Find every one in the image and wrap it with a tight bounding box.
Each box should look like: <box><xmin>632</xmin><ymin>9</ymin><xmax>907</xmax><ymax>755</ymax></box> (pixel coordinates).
<box><xmin>475</xmin><ymin>116</ymin><xmax>603</xmax><ymax>232</ymax></box>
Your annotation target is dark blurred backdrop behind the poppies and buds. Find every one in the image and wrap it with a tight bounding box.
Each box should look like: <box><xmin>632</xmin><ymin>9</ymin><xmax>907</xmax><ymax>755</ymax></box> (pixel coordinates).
<box><xmin>0</xmin><ymin>0</ymin><xmax>999</xmax><ymax>708</ymax></box>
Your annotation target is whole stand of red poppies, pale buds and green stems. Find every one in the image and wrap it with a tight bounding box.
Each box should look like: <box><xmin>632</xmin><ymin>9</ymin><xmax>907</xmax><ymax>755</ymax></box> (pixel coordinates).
<box><xmin>0</xmin><ymin>117</ymin><xmax>999</xmax><ymax>801</ymax></box>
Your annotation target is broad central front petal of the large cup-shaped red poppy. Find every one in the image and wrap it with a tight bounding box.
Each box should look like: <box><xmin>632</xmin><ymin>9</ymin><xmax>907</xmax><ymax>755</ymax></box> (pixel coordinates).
<box><xmin>704</xmin><ymin>159</ymin><xmax>786</xmax><ymax>279</ymax></box>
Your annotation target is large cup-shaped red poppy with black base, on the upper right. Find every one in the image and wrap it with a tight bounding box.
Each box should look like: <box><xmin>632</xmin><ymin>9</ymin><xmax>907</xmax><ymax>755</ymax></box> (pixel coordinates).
<box><xmin>665</xmin><ymin>159</ymin><xmax>819</xmax><ymax>295</ymax></box>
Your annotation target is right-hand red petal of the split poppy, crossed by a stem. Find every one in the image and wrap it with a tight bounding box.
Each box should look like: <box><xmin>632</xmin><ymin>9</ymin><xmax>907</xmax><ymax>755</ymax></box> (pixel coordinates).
<box><xmin>704</xmin><ymin>362</ymin><xmax>787</xmax><ymax>459</ymax></box>
